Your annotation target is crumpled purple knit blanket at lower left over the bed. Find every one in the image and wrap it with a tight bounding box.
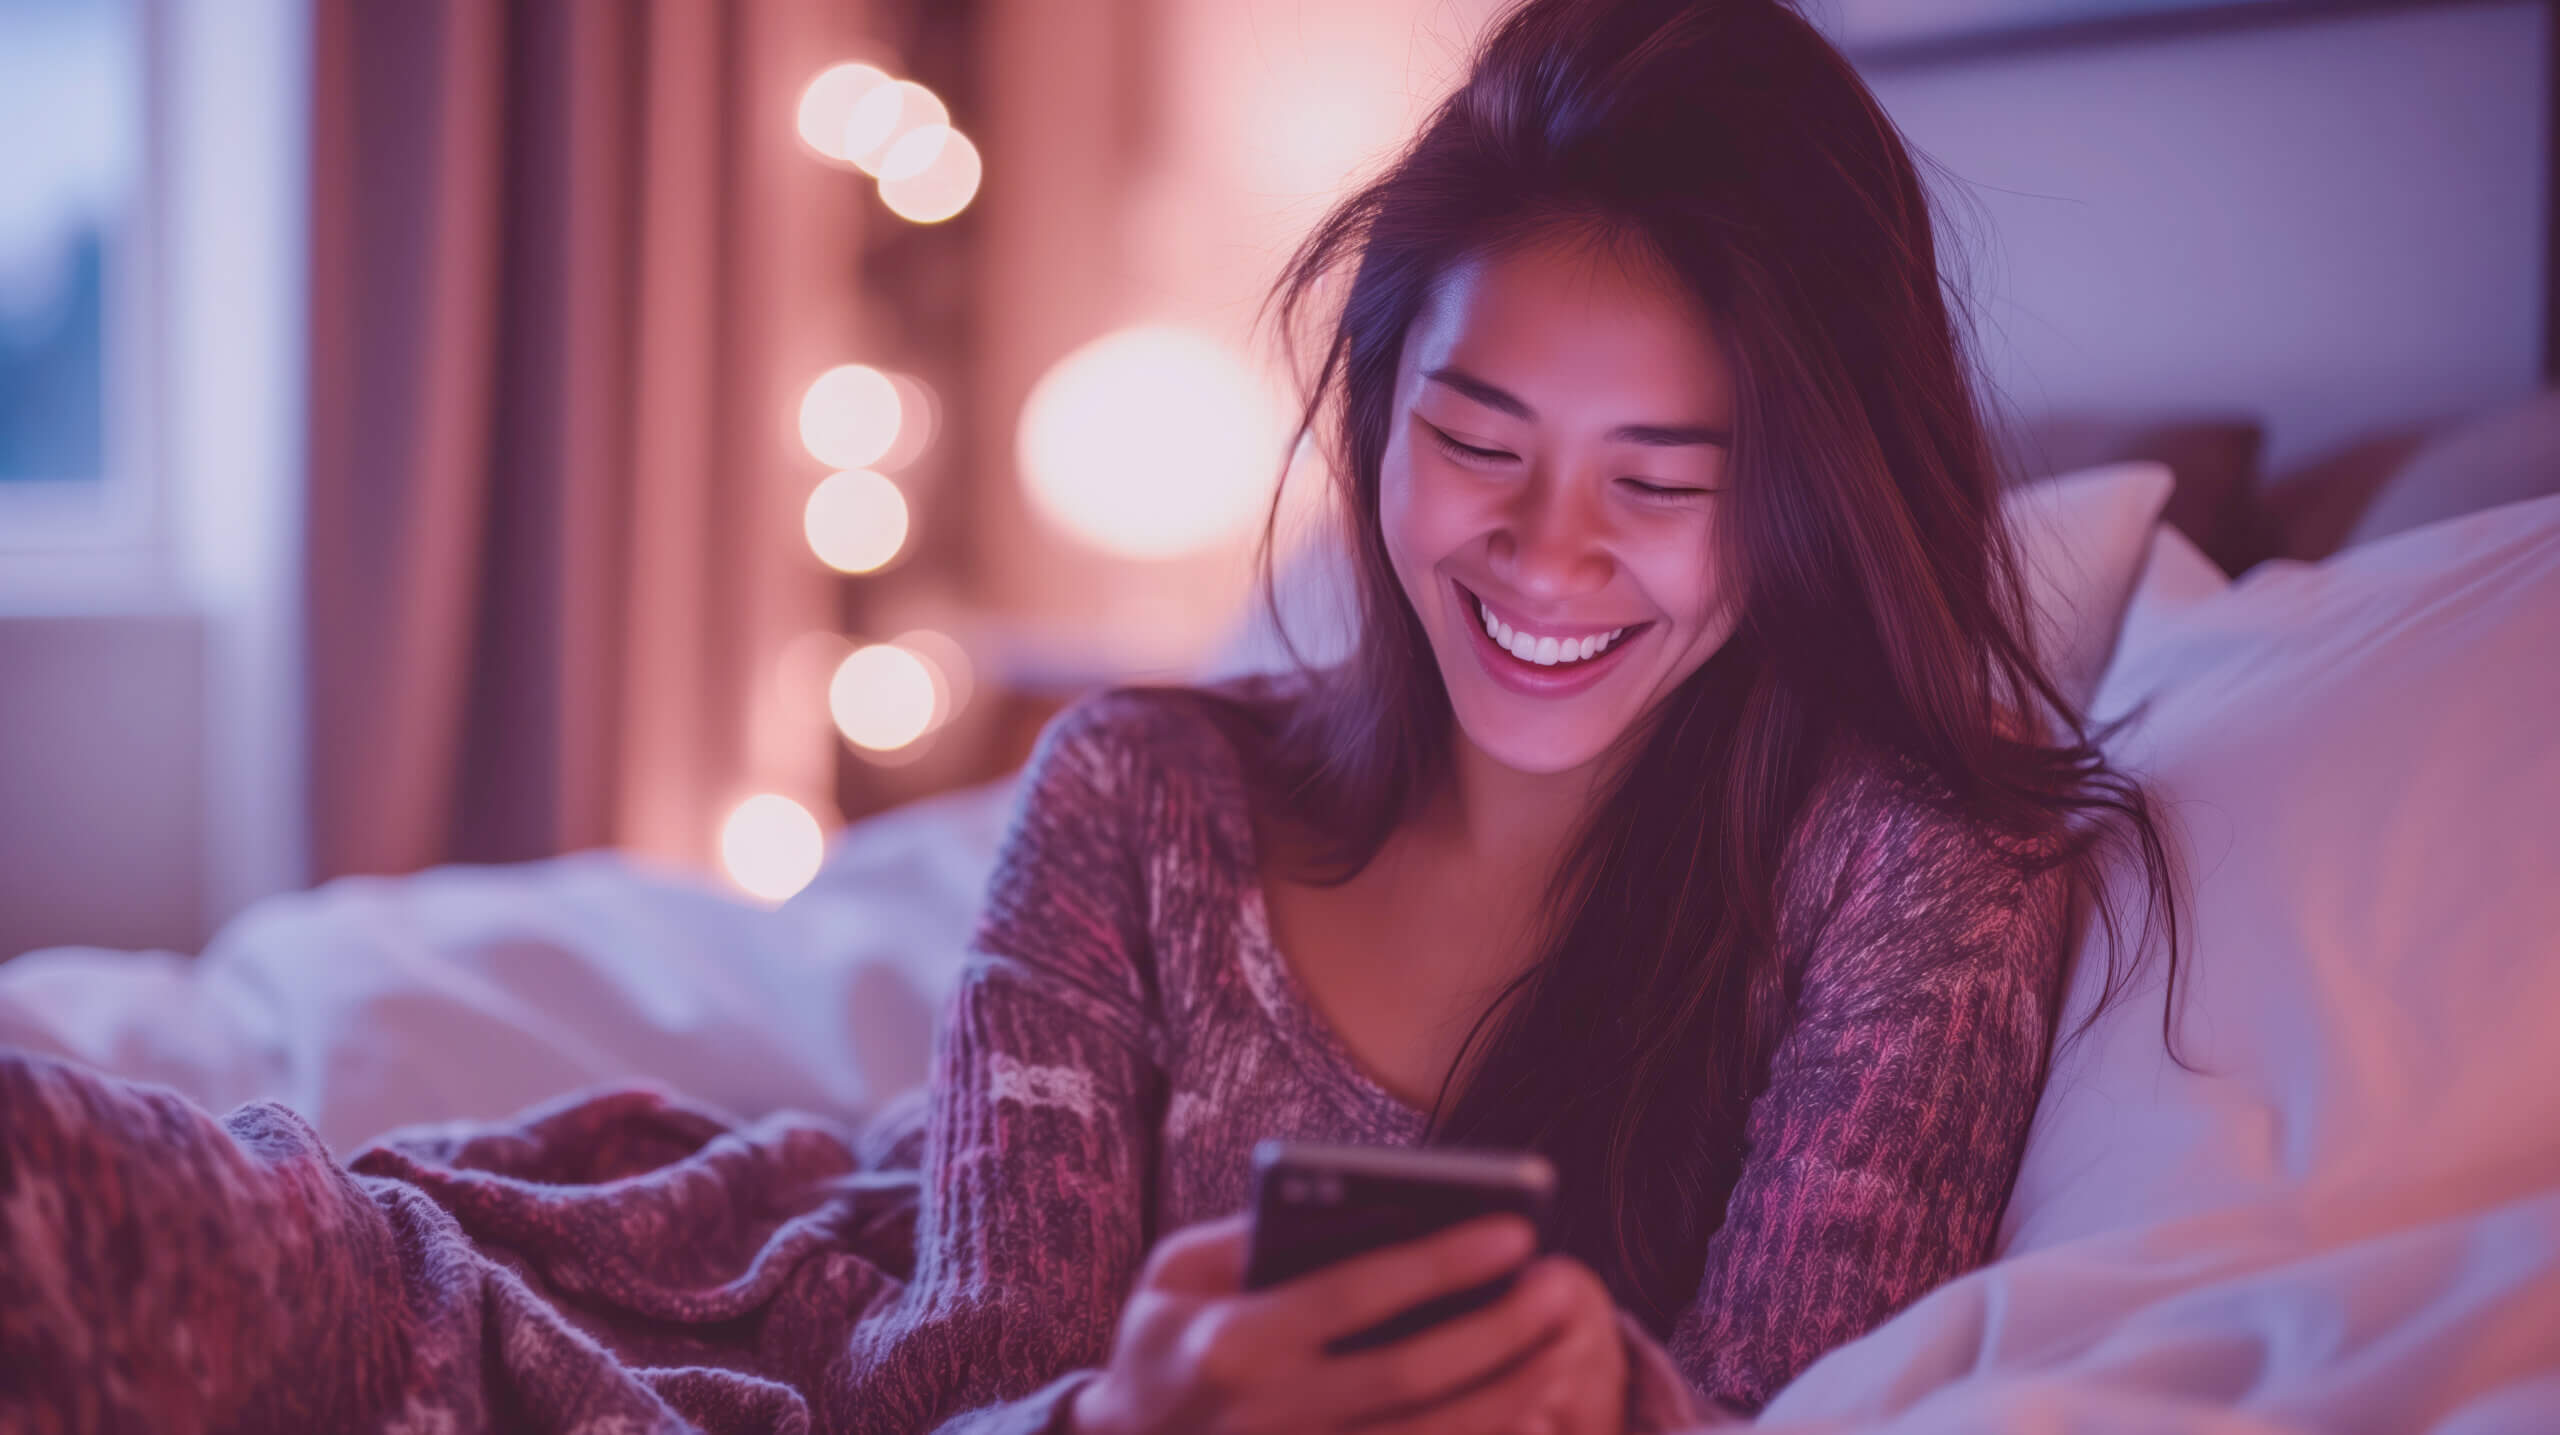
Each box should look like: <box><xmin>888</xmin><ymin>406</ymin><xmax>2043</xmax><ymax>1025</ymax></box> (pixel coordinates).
<box><xmin>0</xmin><ymin>1051</ymin><xmax>932</xmax><ymax>1435</ymax></box>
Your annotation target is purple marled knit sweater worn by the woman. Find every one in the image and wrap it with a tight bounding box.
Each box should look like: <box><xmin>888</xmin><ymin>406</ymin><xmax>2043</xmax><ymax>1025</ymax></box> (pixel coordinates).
<box><xmin>919</xmin><ymin>691</ymin><xmax>2066</xmax><ymax>1427</ymax></box>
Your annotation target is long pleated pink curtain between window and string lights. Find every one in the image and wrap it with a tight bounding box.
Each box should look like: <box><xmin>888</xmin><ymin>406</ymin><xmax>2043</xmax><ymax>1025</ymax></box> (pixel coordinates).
<box><xmin>305</xmin><ymin>0</ymin><xmax>865</xmax><ymax>877</ymax></box>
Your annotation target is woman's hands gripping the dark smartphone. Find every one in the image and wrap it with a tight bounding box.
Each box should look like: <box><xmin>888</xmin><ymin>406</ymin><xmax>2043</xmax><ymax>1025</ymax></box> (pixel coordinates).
<box><xmin>1070</xmin><ymin>1215</ymin><xmax>1626</xmax><ymax>1435</ymax></box>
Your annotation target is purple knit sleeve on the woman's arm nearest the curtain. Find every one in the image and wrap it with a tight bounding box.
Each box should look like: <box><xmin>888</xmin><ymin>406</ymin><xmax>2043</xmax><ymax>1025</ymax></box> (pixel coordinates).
<box><xmin>852</xmin><ymin>696</ymin><xmax>1160</xmax><ymax>1435</ymax></box>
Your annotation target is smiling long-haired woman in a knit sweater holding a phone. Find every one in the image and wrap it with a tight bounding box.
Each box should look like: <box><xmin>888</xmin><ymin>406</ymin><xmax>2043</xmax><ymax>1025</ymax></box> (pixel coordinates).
<box><xmin>947</xmin><ymin>0</ymin><xmax>2173</xmax><ymax>1435</ymax></box>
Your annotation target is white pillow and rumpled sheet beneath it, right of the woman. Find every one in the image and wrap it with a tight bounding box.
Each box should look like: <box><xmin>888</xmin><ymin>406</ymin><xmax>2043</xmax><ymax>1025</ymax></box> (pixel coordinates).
<box><xmin>1764</xmin><ymin>499</ymin><xmax>2560</xmax><ymax>1435</ymax></box>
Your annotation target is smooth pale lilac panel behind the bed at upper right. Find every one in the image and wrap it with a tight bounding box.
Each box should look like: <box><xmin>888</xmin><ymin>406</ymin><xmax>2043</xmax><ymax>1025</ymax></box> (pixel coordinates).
<box><xmin>1871</xmin><ymin>0</ymin><xmax>2552</xmax><ymax>466</ymax></box>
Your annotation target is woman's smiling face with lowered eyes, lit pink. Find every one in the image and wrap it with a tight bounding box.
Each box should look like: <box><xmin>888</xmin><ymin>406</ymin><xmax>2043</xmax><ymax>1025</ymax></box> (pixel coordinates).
<box><xmin>1380</xmin><ymin>232</ymin><xmax>1733</xmax><ymax>772</ymax></box>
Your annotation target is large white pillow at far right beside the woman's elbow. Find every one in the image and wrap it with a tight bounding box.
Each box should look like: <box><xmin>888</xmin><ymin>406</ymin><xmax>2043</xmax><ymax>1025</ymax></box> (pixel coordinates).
<box><xmin>2002</xmin><ymin>499</ymin><xmax>2560</xmax><ymax>1253</ymax></box>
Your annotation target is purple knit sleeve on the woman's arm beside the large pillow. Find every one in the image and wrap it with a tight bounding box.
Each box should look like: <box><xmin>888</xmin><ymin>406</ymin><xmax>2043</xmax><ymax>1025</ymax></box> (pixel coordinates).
<box><xmin>1672</xmin><ymin>765</ymin><xmax>2068</xmax><ymax>1412</ymax></box>
